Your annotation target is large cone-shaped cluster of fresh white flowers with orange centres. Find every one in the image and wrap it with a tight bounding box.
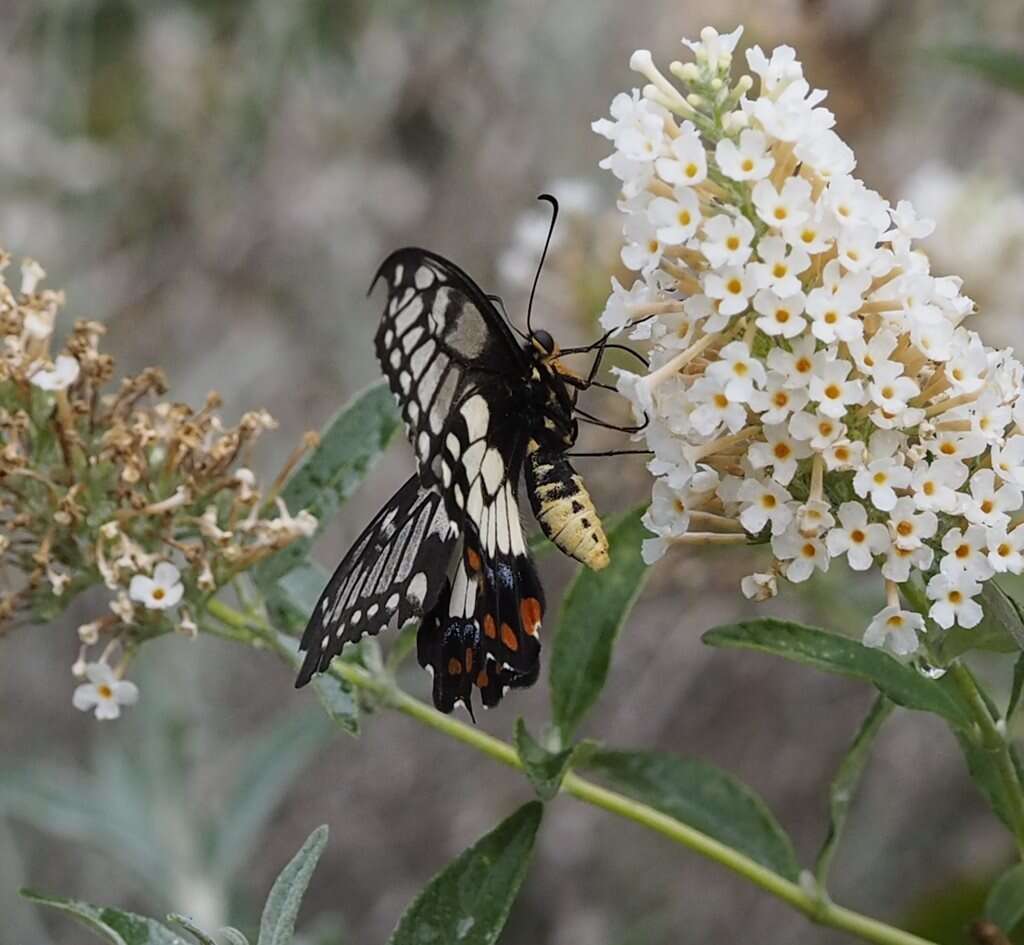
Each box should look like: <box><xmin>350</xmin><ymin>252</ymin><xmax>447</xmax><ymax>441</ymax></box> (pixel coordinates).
<box><xmin>594</xmin><ymin>29</ymin><xmax>1024</xmax><ymax>655</ymax></box>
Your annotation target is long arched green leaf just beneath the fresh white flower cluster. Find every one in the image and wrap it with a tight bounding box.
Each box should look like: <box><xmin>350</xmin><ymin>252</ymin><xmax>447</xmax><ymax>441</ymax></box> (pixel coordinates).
<box><xmin>703</xmin><ymin>618</ymin><xmax>972</xmax><ymax>729</ymax></box>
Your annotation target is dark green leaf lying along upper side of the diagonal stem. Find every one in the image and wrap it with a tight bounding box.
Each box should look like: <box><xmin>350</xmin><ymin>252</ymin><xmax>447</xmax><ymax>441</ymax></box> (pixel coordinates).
<box><xmin>580</xmin><ymin>748</ymin><xmax>800</xmax><ymax>879</ymax></box>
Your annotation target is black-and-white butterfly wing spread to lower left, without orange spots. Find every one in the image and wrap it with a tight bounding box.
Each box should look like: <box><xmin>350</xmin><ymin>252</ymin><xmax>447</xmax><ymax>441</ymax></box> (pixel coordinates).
<box><xmin>296</xmin><ymin>476</ymin><xmax>459</xmax><ymax>686</ymax></box>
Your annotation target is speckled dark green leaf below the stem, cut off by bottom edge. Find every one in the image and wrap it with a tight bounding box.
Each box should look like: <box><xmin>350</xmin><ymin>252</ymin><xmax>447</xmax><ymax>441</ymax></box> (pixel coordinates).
<box><xmin>388</xmin><ymin>801</ymin><xmax>544</xmax><ymax>945</ymax></box>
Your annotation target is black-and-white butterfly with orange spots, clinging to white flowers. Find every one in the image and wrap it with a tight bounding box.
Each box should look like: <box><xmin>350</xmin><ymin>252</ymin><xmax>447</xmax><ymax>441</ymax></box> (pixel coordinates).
<box><xmin>296</xmin><ymin>199</ymin><xmax>634</xmax><ymax>716</ymax></box>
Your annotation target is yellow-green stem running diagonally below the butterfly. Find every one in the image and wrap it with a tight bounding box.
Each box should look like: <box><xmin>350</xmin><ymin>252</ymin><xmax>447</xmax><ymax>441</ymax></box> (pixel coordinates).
<box><xmin>208</xmin><ymin>600</ymin><xmax>934</xmax><ymax>945</ymax></box>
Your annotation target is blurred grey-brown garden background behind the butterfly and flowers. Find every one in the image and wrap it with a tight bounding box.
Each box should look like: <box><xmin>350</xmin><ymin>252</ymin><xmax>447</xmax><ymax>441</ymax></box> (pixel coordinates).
<box><xmin>0</xmin><ymin>0</ymin><xmax>1024</xmax><ymax>945</ymax></box>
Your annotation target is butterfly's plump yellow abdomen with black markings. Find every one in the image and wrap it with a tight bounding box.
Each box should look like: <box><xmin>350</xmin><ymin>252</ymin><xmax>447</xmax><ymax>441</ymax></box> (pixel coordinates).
<box><xmin>526</xmin><ymin>440</ymin><xmax>608</xmax><ymax>571</ymax></box>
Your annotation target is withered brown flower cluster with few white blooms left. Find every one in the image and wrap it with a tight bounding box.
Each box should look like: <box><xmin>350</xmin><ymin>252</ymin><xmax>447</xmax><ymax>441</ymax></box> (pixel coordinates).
<box><xmin>0</xmin><ymin>251</ymin><xmax>316</xmax><ymax>719</ymax></box>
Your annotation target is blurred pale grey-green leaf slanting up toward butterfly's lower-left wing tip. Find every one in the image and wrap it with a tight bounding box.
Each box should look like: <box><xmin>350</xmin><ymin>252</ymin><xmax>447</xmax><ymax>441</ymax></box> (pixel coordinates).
<box><xmin>211</xmin><ymin>707</ymin><xmax>334</xmax><ymax>876</ymax></box>
